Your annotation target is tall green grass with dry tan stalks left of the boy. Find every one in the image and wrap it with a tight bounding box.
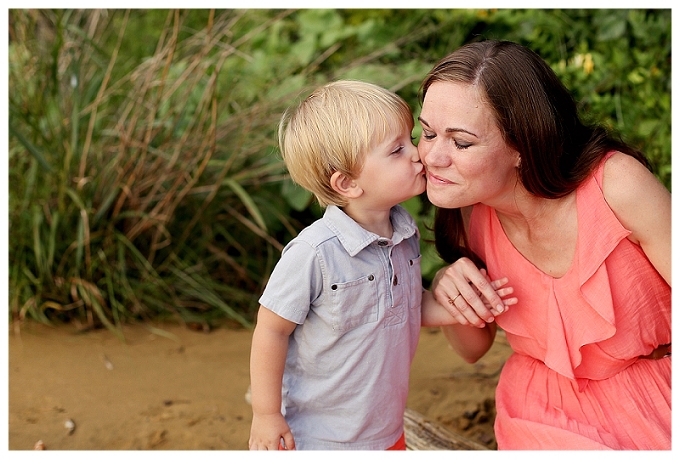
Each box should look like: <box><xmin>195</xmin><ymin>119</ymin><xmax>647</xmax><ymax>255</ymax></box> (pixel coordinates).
<box><xmin>10</xmin><ymin>11</ymin><xmax>296</xmax><ymax>330</ymax></box>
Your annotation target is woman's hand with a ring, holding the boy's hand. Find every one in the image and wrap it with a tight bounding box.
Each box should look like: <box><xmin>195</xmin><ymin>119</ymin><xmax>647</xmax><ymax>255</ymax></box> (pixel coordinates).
<box><xmin>432</xmin><ymin>258</ymin><xmax>517</xmax><ymax>328</ymax></box>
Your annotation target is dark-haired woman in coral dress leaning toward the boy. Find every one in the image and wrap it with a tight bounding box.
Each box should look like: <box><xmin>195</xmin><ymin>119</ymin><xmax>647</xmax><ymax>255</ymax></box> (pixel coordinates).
<box><xmin>418</xmin><ymin>41</ymin><xmax>671</xmax><ymax>449</ymax></box>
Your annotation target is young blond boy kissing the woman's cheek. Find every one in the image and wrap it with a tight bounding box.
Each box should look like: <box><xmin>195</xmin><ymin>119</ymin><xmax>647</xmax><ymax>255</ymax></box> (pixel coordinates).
<box><xmin>249</xmin><ymin>81</ymin><xmax>502</xmax><ymax>450</ymax></box>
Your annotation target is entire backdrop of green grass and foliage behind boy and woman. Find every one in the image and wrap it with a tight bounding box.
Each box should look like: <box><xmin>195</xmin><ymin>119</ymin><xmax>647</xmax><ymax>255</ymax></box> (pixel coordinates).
<box><xmin>8</xmin><ymin>9</ymin><xmax>671</xmax><ymax>331</ymax></box>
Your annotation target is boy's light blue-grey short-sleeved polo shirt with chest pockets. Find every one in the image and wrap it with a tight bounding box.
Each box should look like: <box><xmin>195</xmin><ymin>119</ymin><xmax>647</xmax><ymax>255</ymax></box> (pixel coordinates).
<box><xmin>260</xmin><ymin>206</ymin><xmax>422</xmax><ymax>450</ymax></box>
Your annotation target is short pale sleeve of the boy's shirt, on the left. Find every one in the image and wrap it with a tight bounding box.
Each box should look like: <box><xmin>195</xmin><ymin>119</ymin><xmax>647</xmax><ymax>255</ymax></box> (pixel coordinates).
<box><xmin>260</xmin><ymin>240</ymin><xmax>323</xmax><ymax>324</ymax></box>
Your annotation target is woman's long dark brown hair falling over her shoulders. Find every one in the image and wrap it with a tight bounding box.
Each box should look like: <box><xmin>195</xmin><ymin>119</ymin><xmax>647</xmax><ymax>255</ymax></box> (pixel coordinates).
<box><xmin>420</xmin><ymin>40</ymin><xmax>649</xmax><ymax>263</ymax></box>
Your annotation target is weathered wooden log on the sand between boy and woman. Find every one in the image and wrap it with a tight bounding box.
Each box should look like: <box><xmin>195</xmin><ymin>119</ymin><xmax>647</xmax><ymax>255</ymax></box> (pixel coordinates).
<box><xmin>404</xmin><ymin>408</ymin><xmax>489</xmax><ymax>451</ymax></box>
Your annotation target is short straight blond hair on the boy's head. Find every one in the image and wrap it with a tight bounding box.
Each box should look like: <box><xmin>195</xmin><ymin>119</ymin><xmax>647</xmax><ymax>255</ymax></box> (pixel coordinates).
<box><xmin>279</xmin><ymin>80</ymin><xmax>413</xmax><ymax>207</ymax></box>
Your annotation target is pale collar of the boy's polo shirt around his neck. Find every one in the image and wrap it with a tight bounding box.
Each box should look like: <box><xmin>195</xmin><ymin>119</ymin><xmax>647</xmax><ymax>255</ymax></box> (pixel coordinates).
<box><xmin>323</xmin><ymin>206</ymin><xmax>418</xmax><ymax>257</ymax></box>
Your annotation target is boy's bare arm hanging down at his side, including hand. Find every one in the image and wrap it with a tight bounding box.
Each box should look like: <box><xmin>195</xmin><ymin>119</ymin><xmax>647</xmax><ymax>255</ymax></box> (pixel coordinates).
<box><xmin>248</xmin><ymin>306</ymin><xmax>296</xmax><ymax>450</ymax></box>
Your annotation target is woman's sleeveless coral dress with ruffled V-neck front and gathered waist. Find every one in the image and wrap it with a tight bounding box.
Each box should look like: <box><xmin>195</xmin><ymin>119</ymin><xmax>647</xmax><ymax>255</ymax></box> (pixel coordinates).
<box><xmin>470</xmin><ymin>153</ymin><xmax>671</xmax><ymax>450</ymax></box>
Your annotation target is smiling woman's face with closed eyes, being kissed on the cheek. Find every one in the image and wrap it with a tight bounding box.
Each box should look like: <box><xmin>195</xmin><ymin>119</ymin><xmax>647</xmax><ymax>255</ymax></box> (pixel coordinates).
<box><xmin>418</xmin><ymin>82</ymin><xmax>519</xmax><ymax>208</ymax></box>
